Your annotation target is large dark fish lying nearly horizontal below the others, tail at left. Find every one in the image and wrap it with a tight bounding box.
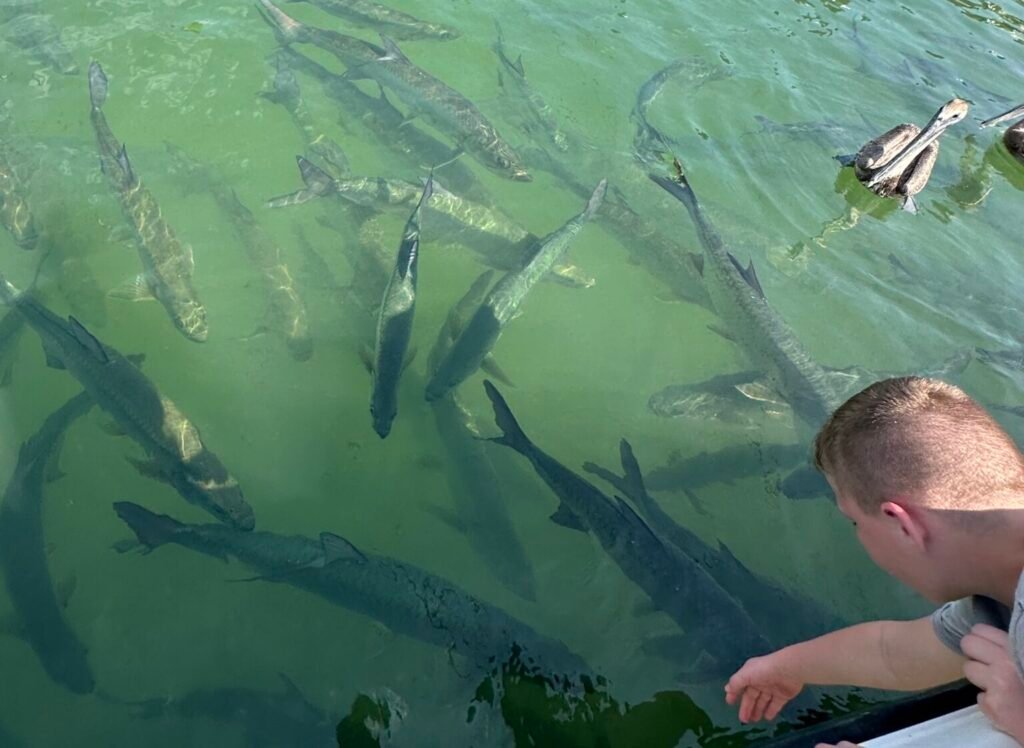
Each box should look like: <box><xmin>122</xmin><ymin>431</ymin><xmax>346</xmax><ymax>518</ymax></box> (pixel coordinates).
<box><xmin>114</xmin><ymin>501</ymin><xmax>588</xmax><ymax>675</ymax></box>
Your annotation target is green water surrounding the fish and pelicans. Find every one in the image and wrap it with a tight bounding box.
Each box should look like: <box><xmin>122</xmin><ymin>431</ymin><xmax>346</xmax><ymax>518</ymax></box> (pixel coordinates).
<box><xmin>0</xmin><ymin>0</ymin><xmax>1024</xmax><ymax>746</ymax></box>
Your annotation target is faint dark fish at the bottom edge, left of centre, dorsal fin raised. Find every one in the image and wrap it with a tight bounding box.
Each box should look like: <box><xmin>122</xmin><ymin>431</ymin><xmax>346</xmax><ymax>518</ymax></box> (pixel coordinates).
<box><xmin>130</xmin><ymin>673</ymin><xmax>335</xmax><ymax>748</ymax></box>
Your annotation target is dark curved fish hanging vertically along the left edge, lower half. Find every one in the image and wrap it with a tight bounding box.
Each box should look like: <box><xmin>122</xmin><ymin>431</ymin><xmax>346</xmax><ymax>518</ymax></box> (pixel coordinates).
<box><xmin>0</xmin><ymin>392</ymin><xmax>96</xmax><ymax>694</ymax></box>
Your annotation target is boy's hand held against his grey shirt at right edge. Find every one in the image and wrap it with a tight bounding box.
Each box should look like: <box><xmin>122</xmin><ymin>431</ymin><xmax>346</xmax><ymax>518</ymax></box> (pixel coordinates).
<box><xmin>961</xmin><ymin>623</ymin><xmax>1024</xmax><ymax>745</ymax></box>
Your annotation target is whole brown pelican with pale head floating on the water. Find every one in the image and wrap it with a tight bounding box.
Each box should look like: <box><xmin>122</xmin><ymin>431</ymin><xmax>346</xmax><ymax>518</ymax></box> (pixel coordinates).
<box><xmin>837</xmin><ymin>98</ymin><xmax>968</xmax><ymax>212</ymax></box>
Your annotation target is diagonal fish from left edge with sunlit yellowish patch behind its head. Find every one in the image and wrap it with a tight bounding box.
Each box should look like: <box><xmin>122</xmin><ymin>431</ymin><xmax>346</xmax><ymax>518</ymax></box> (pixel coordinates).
<box><xmin>0</xmin><ymin>276</ymin><xmax>256</xmax><ymax>530</ymax></box>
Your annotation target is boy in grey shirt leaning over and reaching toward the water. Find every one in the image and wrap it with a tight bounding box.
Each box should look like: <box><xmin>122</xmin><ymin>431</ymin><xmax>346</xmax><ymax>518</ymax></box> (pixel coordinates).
<box><xmin>725</xmin><ymin>377</ymin><xmax>1024</xmax><ymax>746</ymax></box>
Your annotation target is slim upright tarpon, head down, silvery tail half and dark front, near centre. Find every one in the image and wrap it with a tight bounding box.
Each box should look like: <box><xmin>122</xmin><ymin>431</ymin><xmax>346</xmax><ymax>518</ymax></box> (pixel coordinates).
<box><xmin>370</xmin><ymin>174</ymin><xmax>434</xmax><ymax>439</ymax></box>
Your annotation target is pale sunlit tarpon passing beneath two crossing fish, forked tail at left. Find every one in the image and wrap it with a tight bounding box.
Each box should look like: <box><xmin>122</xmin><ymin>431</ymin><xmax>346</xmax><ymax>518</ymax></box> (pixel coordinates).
<box><xmin>267</xmin><ymin>156</ymin><xmax>595</xmax><ymax>288</ymax></box>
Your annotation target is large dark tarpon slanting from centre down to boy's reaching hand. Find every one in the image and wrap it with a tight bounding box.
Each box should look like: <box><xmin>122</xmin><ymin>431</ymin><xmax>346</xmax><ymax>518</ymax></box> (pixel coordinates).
<box><xmin>483</xmin><ymin>381</ymin><xmax>771</xmax><ymax>677</ymax></box>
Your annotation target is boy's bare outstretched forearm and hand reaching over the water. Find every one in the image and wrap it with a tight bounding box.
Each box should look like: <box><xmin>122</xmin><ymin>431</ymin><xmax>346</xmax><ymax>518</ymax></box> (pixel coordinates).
<box><xmin>725</xmin><ymin>617</ymin><xmax>965</xmax><ymax>722</ymax></box>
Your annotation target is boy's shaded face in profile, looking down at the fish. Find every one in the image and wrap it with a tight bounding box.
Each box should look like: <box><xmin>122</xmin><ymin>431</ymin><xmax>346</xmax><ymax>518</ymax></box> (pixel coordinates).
<box><xmin>826</xmin><ymin>475</ymin><xmax>949</xmax><ymax>602</ymax></box>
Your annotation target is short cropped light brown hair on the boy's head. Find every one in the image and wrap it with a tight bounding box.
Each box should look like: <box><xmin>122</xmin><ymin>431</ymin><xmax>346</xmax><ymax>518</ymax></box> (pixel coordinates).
<box><xmin>814</xmin><ymin>377</ymin><xmax>1024</xmax><ymax>512</ymax></box>
